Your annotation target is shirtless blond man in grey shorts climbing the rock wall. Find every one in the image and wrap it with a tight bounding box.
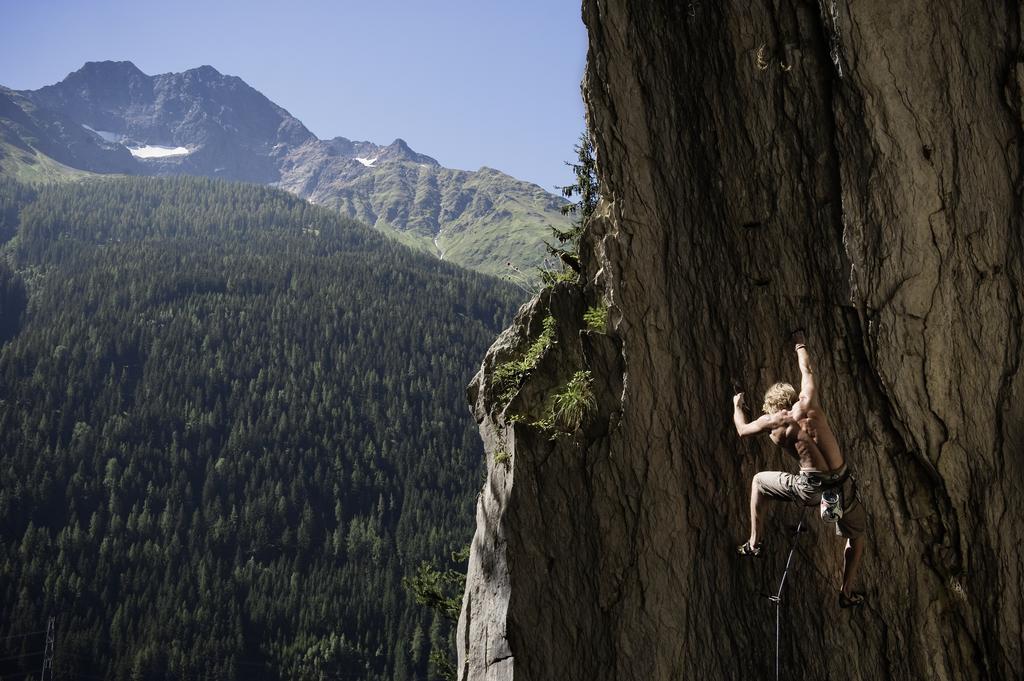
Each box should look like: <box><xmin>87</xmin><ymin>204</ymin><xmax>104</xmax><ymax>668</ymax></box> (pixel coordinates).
<box><xmin>732</xmin><ymin>333</ymin><xmax>866</xmax><ymax>607</ymax></box>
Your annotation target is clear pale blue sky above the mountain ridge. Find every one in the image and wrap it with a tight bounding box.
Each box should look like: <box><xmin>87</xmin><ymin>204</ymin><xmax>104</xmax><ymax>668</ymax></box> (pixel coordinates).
<box><xmin>0</xmin><ymin>0</ymin><xmax>587</xmax><ymax>191</ymax></box>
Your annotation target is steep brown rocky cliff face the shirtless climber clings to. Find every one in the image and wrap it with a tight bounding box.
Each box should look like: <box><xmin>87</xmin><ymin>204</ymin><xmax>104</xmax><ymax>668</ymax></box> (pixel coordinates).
<box><xmin>458</xmin><ymin>0</ymin><xmax>1024</xmax><ymax>681</ymax></box>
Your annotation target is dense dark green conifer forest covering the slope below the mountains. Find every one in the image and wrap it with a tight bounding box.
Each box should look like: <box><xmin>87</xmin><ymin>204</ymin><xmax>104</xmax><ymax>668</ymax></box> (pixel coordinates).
<box><xmin>0</xmin><ymin>178</ymin><xmax>517</xmax><ymax>681</ymax></box>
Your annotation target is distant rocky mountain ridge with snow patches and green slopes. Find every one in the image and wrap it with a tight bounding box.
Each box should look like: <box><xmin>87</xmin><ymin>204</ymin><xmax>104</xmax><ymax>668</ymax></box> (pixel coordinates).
<box><xmin>0</xmin><ymin>61</ymin><xmax>568</xmax><ymax>274</ymax></box>
